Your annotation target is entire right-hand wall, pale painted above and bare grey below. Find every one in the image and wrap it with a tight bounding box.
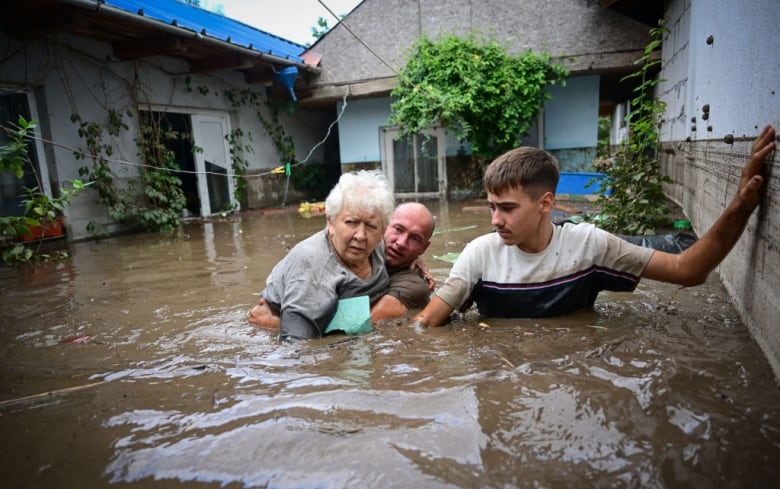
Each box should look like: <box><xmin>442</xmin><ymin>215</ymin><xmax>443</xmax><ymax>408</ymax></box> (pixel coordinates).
<box><xmin>658</xmin><ymin>0</ymin><xmax>780</xmax><ymax>377</ymax></box>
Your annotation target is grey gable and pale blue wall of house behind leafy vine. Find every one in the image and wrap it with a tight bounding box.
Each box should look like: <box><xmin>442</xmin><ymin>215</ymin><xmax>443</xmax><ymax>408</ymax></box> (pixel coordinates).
<box><xmin>300</xmin><ymin>0</ymin><xmax>648</xmax><ymax>189</ymax></box>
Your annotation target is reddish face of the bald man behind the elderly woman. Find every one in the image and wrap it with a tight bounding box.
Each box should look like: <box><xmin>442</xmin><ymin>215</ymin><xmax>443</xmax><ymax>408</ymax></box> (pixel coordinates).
<box><xmin>385</xmin><ymin>206</ymin><xmax>431</xmax><ymax>268</ymax></box>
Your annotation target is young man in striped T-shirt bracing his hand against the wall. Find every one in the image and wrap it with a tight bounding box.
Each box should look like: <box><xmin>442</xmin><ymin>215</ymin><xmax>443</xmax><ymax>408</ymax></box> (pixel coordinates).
<box><xmin>414</xmin><ymin>125</ymin><xmax>776</xmax><ymax>326</ymax></box>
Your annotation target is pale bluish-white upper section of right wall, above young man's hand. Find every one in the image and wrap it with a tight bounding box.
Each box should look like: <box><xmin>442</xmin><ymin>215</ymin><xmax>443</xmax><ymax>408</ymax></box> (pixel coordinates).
<box><xmin>659</xmin><ymin>0</ymin><xmax>780</xmax><ymax>141</ymax></box>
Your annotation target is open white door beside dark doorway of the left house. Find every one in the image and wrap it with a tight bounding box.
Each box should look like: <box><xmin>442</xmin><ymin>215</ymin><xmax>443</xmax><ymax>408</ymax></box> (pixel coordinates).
<box><xmin>192</xmin><ymin>115</ymin><xmax>238</xmax><ymax>217</ymax></box>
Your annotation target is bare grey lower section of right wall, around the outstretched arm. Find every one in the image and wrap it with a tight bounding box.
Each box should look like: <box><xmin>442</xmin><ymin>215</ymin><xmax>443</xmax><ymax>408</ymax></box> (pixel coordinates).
<box><xmin>661</xmin><ymin>138</ymin><xmax>780</xmax><ymax>379</ymax></box>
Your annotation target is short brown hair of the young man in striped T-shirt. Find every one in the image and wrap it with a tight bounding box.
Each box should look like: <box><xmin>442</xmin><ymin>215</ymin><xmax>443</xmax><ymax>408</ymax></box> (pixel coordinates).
<box><xmin>483</xmin><ymin>146</ymin><xmax>559</xmax><ymax>198</ymax></box>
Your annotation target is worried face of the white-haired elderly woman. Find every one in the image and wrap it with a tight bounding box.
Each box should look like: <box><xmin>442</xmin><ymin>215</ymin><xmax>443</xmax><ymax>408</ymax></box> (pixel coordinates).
<box><xmin>328</xmin><ymin>206</ymin><xmax>384</xmax><ymax>271</ymax></box>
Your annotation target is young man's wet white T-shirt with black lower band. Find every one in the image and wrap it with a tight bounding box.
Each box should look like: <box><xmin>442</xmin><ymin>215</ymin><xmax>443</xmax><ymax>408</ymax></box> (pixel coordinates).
<box><xmin>436</xmin><ymin>223</ymin><xmax>654</xmax><ymax>318</ymax></box>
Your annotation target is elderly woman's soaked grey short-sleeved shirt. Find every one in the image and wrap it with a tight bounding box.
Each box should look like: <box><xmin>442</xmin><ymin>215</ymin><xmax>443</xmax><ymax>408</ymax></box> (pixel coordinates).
<box><xmin>262</xmin><ymin>229</ymin><xmax>389</xmax><ymax>339</ymax></box>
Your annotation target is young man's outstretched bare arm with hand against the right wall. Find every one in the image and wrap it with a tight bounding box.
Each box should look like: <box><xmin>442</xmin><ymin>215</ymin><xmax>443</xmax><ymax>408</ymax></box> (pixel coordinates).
<box><xmin>642</xmin><ymin>125</ymin><xmax>776</xmax><ymax>286</ymax></box>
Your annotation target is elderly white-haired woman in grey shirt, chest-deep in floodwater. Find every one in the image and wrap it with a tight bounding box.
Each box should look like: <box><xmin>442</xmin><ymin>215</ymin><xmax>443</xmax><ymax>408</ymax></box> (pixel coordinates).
<box><xmin>262</xmin><ymin>171</ymin><xmax>394</xmax><ymax>340</ymax></box>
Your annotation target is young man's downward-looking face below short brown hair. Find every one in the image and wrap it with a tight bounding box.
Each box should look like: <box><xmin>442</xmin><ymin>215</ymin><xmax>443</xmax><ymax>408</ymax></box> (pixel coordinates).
<box><xmin>487</xmin><ymin>188</ymin><xmax>553</xmax><ymax>253</ymax></box>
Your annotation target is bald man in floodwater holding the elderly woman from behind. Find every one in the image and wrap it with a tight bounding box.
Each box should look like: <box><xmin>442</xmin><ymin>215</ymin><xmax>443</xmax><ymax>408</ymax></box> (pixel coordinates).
<box><xmin>249</xmin><ymin>202</ymin><xmax>434</xmax><ymax>329</ymax></box>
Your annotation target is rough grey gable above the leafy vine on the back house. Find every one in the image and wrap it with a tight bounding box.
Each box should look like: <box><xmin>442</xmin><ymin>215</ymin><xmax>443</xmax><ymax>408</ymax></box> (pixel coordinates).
<box><xmin>304</xmin><ymin>0</ymin><xmax>648</xmax><ymax>86</ymax></box>
